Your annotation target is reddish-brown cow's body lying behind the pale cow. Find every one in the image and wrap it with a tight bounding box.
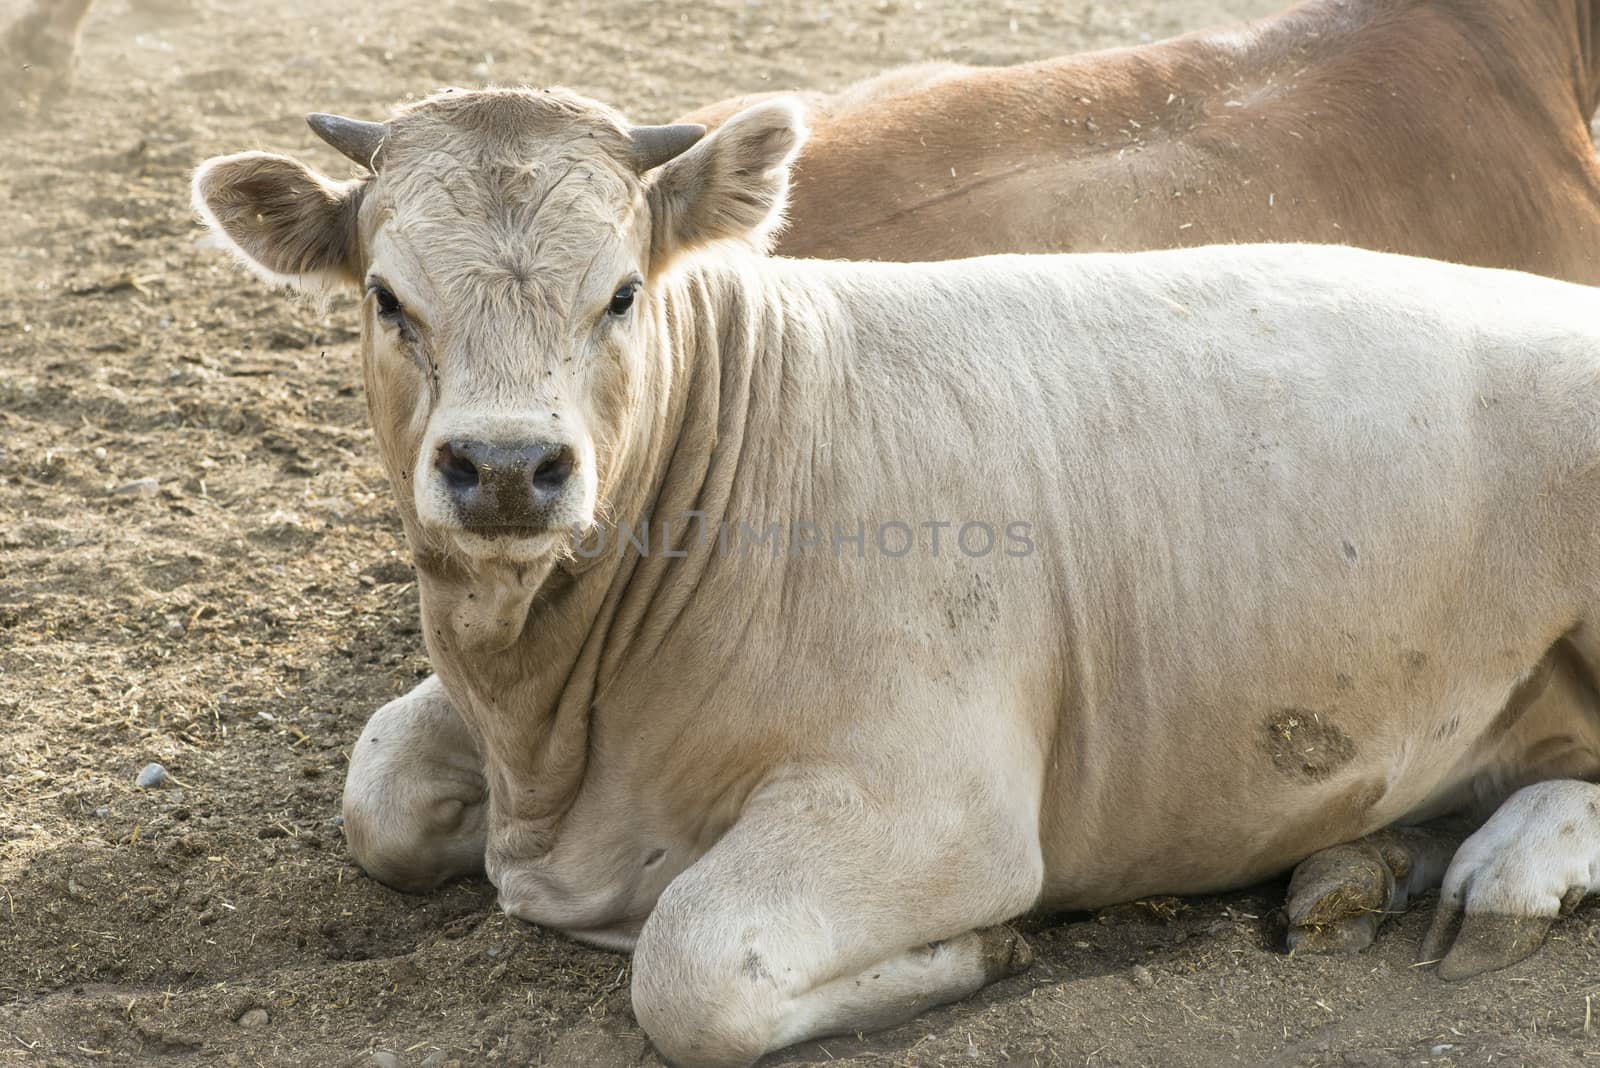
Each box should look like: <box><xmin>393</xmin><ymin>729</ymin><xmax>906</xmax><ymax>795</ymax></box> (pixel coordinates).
<box><xmin>690</xmin><ymin>0</ymin><xmax>1600</xmax><ymax>283</ymax></box>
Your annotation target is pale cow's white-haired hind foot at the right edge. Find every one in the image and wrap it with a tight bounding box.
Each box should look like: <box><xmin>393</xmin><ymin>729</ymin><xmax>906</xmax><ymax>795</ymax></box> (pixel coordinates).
<box><xmin>1421</xmin><ymin>779</ymin><xmax>1600</xmax><ymax>978</ymax></box>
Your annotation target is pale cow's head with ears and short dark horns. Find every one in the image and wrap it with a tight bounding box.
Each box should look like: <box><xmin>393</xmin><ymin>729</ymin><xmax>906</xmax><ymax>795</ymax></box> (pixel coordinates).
<box><xmin>194</xmin><ymin>90</ymin><xmax>805</xmax><ymax>563</ymax></box>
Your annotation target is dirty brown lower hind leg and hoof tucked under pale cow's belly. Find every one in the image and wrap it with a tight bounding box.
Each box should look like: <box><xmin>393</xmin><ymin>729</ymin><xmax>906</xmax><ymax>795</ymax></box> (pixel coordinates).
<box><xmin>1285</xmin><ymin>820</ymin><xmax>1470</xmax><ymax>953</ymax></box>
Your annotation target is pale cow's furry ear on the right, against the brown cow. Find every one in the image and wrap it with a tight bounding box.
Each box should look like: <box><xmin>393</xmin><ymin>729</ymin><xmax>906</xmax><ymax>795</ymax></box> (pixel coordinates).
<box><xmin>650</xmin><ymin>99</ymin><xmax>808</xmax><ymax>272</ymax></box>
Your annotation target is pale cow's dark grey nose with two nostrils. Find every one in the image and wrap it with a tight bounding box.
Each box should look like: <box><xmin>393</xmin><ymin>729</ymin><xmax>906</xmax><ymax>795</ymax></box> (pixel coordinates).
<box><xmin>434</xmin><ymin>441</ymin><xmax>574</xmax><ymax>534</ymax></box>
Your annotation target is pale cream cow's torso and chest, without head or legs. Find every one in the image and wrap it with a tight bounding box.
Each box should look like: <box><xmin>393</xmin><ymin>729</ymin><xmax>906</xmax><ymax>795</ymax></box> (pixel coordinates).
<box><xmin>403</xmin><ymin>248</ymin><xmax>1600</xmax><ymax>946</ymax></box>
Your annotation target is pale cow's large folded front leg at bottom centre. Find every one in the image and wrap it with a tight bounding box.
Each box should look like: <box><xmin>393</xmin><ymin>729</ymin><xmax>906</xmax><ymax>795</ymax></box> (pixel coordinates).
<box><xmin>634</xmin><ymin>775</ymin><xmax>1043</xmax><ymax>1068</ymax></box>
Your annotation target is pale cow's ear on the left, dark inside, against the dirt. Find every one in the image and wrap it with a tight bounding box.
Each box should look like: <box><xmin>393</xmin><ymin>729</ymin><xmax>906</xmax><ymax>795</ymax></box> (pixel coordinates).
<box><xmin>194</xmin><ymin>152</ymin><xmax>366</xmax><ymax>294</ymax></box>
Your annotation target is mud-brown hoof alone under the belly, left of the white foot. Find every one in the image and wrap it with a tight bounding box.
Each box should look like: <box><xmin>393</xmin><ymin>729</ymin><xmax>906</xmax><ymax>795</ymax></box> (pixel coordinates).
<box><xmin>1285</xmin><ymin>838</ymin><xmax>1410</xmax><ymax>953</ymax></box>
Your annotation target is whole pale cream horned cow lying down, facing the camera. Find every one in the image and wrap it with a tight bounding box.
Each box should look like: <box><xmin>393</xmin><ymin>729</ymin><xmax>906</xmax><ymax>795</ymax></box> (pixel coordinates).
<box><xmin>195</xmin><ymin>91</ymin><xmax>1600</xmax><ymax>1065</ymax></box>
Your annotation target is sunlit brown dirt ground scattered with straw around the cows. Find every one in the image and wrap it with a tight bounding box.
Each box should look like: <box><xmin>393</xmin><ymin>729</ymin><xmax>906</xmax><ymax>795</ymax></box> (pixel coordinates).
<box><xmin>0</xmin><ymin>0</ymin><xmax>1600</xmax><ymax>1066</ymax></box>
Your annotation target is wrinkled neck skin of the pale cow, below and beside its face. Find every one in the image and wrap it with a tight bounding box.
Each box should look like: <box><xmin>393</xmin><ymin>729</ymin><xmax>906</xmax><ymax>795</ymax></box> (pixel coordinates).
<box><xmin>395</xmin><ymin>259</ymin><xmax>774</xmax><ymax>879</ymax></box>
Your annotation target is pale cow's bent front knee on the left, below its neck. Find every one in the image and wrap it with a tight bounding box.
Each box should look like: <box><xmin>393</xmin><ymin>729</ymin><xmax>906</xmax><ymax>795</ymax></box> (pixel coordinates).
<box><xmin>344</xmin><ymin>676</ymin><xmax>488</xmax><ymax>894</ymax></box>
